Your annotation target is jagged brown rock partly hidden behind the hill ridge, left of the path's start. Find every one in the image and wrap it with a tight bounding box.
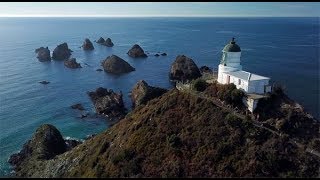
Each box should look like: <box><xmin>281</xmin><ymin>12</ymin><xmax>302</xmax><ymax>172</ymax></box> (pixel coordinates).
<box><xmin>131</xmin><ymin>80</ymin><xmax>168</xmax><ymax>107</ymax></box>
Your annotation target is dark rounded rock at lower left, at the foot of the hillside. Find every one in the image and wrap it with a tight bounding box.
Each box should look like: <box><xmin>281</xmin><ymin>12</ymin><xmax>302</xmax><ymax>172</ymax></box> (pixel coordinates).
<box><xmin>8</xmin><ymin>124</ymin><xmax>67</xmax><ymax>166</ymax></box>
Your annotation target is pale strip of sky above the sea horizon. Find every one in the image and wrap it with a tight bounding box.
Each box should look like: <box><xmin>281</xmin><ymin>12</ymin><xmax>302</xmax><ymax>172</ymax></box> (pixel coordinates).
<box><xmin>0</xmin><ymin>2</ymin><xmax>320</xmax><ymax>17</ymax></box>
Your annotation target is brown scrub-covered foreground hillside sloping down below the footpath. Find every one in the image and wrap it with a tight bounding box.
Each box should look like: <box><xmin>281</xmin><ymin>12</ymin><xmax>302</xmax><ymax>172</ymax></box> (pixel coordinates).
<box><xmin>10</xmin><ymin>89</ymin><xmax>320</xmax><ymax>177</ymax></box>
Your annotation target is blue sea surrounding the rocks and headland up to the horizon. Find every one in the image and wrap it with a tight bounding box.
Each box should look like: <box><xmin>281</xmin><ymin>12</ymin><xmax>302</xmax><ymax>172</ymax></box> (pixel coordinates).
<box><xmin>0</xmin><ymin>18</ymin><xmax>320</xmax><ymax>176</ymax></box>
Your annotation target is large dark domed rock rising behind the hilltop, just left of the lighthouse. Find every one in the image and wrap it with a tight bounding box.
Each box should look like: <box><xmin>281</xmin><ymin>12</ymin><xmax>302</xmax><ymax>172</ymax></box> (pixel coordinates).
<box><xmin>169</xmin><ymin>55</ymin><xmax>201</xmax><ymax>82</ymax></box>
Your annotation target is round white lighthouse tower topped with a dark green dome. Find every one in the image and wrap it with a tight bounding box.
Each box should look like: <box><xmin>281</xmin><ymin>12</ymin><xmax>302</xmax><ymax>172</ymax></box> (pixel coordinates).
<box><xmin>218</xmin><ymin>38</ymin><xmax>242</xmax><ymax>84</ymax></box>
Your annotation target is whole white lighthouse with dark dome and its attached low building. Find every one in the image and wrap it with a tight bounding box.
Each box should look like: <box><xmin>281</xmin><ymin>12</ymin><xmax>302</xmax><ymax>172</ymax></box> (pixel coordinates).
<box><xmin>218</xmin><ymin>38</ymin><xmax>271</xmax><ymax>112</ymax></box>
